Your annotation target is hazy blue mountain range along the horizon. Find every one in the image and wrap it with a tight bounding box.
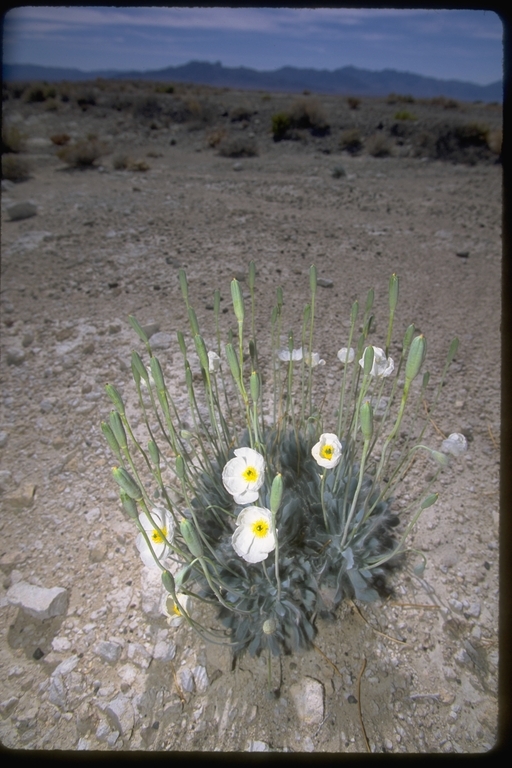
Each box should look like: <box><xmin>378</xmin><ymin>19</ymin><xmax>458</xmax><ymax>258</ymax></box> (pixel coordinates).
<box><xmin>3</xmin><ymin>61</ymin><xmax>503</xmax><ymax>102</ymax></box>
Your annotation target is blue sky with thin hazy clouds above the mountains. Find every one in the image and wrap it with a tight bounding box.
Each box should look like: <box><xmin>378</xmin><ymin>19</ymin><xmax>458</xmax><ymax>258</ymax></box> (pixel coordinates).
<box><xmin>3</xmin><ymin>6</ymin><xmax>503</xmax><ymax>85</ymax></box>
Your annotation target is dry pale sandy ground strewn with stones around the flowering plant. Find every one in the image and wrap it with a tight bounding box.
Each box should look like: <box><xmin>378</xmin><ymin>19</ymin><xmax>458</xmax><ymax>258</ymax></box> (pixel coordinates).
<box><xmin>0</xmin><ymin>84</ymin><xmax>501</xmax><ymax>753</ymax></box>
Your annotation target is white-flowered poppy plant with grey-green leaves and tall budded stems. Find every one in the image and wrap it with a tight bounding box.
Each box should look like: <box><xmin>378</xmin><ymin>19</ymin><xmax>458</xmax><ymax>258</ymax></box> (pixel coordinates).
<box><xmin>102</xmin><ymin>262</ymin><xmax>467</xmax><ymax>658</ymax></box>
